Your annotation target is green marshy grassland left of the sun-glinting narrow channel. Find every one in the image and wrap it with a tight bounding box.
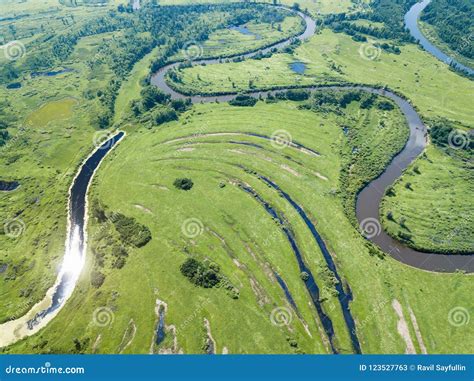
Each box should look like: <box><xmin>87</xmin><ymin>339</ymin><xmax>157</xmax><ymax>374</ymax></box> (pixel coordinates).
<box><xmin>0</xmin><ymin>10</ymin><xmax>118</xmax><ymax>321</ymax></box>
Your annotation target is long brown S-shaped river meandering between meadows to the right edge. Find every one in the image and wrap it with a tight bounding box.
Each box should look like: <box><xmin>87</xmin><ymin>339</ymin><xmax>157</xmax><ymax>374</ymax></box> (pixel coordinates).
<box><xmin>151</xmin><ymin>5</ymin><xmax>474</xmax><ymax>273</ymax></box>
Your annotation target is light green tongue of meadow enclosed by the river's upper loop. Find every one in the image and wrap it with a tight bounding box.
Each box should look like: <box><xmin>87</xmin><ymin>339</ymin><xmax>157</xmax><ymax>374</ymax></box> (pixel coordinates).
<box><xmin>168</xmin><ymin>29</ymin><xmax>474</xmax><ymax>125</ymax></box>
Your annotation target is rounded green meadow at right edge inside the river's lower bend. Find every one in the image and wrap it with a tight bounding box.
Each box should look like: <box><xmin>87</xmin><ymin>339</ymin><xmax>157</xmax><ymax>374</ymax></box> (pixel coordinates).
<box><xmin>381</xmin><ymin>146</ymin><xmax>474</xmax><ymax>253</ymax></box>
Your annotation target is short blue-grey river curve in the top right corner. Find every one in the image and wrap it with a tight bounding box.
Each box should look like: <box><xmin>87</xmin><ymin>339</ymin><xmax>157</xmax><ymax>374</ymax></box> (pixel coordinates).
<box><xmin>405</xmin><ymin>0</ymin><xmax>474</xmax><ymax>75</ymax></box>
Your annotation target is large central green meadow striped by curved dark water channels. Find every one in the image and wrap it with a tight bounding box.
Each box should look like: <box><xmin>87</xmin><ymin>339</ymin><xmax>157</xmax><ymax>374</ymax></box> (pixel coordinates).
<box><xmin>4</xmin><ymin>102</ymin><xmax>474</xmax><ymax>353</ymax></box>
